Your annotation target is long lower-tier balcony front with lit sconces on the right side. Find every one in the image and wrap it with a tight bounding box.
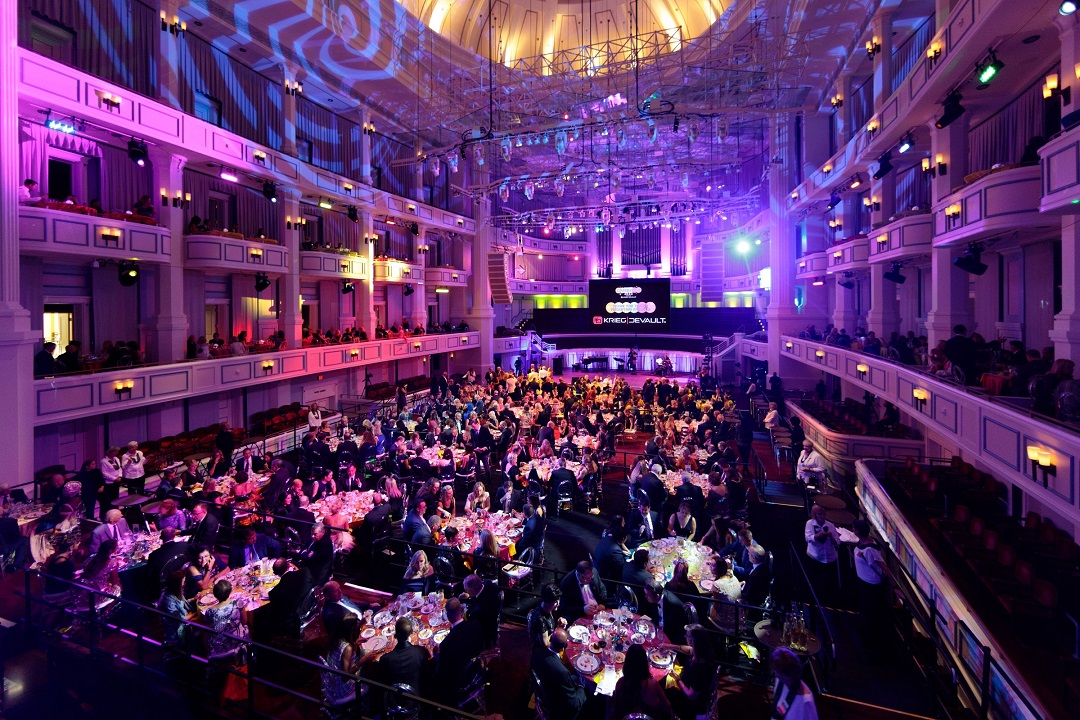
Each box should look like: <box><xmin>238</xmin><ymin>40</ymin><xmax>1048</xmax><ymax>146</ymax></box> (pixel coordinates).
<box><xmin>781</xmin><ymin>336</ymin><xmax>1080</xmax><ymax>538</ymax></box>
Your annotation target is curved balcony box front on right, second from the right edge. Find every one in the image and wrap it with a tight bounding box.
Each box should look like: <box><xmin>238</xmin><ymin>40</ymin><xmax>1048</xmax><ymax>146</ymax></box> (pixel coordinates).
<box><xmin>934</xmin><ymin>165</ymin><xmax>1047</xmax><ymax>247</ymax></box>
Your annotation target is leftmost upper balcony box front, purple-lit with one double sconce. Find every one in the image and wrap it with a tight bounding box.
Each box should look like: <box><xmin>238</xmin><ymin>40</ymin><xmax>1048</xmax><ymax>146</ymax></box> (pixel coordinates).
<box><xmin>18</xmin><ymin>203</ymin><xmax>173</xmax><ymax>262</ymax></box>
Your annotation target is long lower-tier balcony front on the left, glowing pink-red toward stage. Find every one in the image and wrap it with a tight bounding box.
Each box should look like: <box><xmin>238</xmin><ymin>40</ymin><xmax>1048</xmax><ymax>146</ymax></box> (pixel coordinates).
<box><xmin>33</xmin><ymin>332</ymin><xmax>480</xmax><ymax>425</ymax></box>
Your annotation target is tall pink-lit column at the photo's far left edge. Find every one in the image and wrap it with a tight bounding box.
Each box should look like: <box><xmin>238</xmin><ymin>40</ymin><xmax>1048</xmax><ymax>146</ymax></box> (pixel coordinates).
<box><xmin>0</xmin><ymin>2</ymin><xmax>36</xmax><ymax>484</ymax></box>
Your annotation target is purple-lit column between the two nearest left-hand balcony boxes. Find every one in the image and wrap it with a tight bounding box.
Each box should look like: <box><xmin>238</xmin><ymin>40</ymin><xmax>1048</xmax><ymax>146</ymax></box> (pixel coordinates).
<box><xmin>150</xmin><ymin>146</ymin><xmax>189</xmax><ymax>363</ymax></box>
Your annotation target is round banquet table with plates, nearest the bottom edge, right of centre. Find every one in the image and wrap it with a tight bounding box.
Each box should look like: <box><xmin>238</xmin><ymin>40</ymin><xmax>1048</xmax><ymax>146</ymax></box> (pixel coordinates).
<box><xmin>565</xmin><ymin>608</ymin><xmax>675</xmax><ymax>696</ymax></box>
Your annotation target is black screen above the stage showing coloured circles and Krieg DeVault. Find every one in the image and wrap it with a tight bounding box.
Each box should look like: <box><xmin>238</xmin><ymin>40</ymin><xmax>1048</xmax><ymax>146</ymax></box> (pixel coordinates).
<box><xmin>589</xmin><ymin>277</ymin><xmax>672</xmax><ymax>332</ymax></box>
